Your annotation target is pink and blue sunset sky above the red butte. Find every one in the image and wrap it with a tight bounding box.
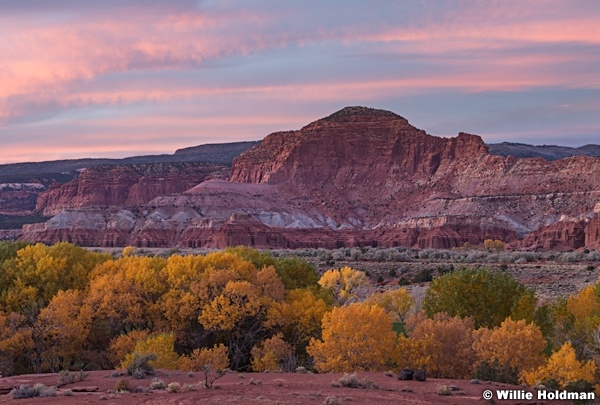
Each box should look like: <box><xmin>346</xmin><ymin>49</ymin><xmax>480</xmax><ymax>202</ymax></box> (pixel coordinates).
<box><xmin>0</xmin><ymin>0</ymin><xmax>600</xmax><ymax>163</ymax></box>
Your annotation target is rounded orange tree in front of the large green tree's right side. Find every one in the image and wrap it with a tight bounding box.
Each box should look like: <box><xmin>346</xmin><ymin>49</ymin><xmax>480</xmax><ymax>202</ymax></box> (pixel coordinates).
<box><xmin>473</xmin><ymin>318</ymin><xmax>546</xmax><ymax>371</ymax></box>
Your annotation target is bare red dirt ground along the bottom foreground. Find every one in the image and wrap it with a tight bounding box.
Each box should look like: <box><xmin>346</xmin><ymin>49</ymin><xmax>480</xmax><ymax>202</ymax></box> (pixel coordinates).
<box><xmin>0</xmin><ymin>370</ymin><xmax>576</xmax><ymax>405</ymax></box>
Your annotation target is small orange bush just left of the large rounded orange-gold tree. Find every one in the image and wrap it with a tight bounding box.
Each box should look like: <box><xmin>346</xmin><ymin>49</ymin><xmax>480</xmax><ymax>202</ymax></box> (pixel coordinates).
<box><xmin>252</xmin><ymin>333</ymin><xmax>293</xmax><ymax>372</ymax></box>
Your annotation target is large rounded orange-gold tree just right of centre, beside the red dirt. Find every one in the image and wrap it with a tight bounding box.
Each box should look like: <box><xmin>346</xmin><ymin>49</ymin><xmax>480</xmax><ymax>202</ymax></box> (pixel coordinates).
<box><xmin>307</xmin><ymin>303</ymin><xmax>396</xmax><ymax>372</ymax></box>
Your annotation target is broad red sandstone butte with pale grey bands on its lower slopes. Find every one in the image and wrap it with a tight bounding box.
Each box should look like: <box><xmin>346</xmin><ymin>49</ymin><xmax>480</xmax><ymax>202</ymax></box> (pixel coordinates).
<box><xmin>23</xmin><ymin>107</ymin><xmax>600</xmax><ymax>250</ymax></box>
